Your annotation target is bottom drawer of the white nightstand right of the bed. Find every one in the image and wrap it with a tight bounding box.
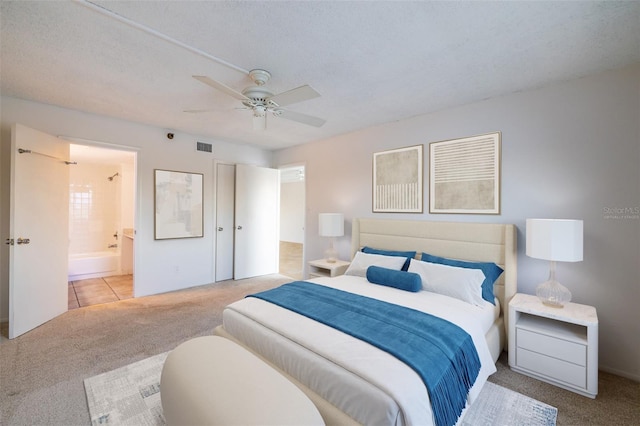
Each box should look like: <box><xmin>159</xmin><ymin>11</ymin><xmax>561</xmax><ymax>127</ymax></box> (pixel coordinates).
<box><xmin>516</xmin><ymin>348</ymin><xmax>587</xmax><ymax>388</ymax></box>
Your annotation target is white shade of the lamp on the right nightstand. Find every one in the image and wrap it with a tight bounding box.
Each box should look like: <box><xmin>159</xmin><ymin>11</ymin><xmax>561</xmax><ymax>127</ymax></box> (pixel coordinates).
<box><xmin>527</xmin><ymin>219</ymin><xmax>583</xmax><ymax>262</ymax></box>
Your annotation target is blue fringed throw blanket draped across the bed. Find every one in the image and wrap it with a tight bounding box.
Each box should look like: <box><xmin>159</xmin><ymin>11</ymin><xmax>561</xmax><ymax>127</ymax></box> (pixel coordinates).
<box><xmin>248</xmin><ymin>281</ymin><xmax>480</xmax><ymax>426</ymax></box>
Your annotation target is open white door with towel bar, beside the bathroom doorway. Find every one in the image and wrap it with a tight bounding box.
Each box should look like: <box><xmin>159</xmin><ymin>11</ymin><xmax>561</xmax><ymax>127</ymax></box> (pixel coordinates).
<box><xmin>9</xmin><ymin>124</ymin><xmax>73</xmax><ymax>339</ymax></box>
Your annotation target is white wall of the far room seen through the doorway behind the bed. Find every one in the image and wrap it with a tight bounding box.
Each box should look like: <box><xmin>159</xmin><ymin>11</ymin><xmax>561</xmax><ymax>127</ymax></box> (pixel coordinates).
<box><xmin>280</xmin><ymin>181</ymin><xmax>305</xmax><ymax>244</ymax></box>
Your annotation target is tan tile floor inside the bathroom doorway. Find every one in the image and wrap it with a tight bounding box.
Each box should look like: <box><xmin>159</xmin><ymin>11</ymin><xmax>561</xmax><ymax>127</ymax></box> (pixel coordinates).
<box><xmin>69</xmin><ymin>275</ymin><xmax>133</xmax><ymax>309</ymax></box>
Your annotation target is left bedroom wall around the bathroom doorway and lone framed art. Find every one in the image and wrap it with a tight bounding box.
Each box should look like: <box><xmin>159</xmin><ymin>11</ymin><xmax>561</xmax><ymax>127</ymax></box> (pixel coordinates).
<box><xmin>0</xmin><ymin>97</ymin><xmax>272</xmax><ymax>320</ymax></box>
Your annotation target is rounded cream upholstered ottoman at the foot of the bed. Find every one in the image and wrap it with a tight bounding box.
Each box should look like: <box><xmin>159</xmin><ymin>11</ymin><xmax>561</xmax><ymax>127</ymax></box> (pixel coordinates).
<box><xmin>160</xmin><ymin>336</ymin><xmax>324</xmax><ymax>425</ymax></box>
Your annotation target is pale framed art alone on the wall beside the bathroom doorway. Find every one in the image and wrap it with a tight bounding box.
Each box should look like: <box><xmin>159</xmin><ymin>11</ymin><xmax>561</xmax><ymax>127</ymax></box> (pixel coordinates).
<box><xmin>154</xmin><ymin>169</ymin><xmax>204</xmax><ymax>240</ymax></box>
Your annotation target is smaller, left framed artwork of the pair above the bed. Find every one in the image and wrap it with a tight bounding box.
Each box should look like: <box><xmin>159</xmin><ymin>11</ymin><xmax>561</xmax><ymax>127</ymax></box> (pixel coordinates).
<box><xmin>373</xmin><ymin>145</ymin><xmax>423</xmax><ymax>213</ymax></box>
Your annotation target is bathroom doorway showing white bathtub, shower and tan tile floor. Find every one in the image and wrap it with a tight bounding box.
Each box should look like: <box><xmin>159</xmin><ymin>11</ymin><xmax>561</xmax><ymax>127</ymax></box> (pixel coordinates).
<box><xmin>68</xmin><ymin>143</ymin><xmax>136</xmax><ymax>309</ymax></box>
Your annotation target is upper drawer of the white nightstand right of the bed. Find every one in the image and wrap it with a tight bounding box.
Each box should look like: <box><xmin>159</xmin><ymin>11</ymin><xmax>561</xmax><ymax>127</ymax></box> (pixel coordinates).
<box><xmin>516</xmin><ymin>328</ymin><xmax>587</xmax><ymax>367</ymax></box>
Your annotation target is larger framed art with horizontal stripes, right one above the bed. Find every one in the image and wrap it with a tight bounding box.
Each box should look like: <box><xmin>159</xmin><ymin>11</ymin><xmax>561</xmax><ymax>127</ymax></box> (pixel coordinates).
<box><xmin>429</xmin><ymin>132</ymin><xmax>501</xmax><ymax>214</ymax></box>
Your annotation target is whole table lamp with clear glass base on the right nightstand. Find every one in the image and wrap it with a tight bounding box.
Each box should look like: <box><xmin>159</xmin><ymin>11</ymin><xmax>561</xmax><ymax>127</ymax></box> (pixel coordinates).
<box><xmin>526</xmin><ymin>219</ymin><xmax>583</xmax><ymax>308</ymax></box>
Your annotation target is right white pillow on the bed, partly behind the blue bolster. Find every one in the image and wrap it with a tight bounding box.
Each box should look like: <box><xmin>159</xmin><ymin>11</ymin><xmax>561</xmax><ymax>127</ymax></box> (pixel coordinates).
<box><xmin>409</xmin><ymin>259</ymin><xmax>485</xmax><ymax>306</ymax></box>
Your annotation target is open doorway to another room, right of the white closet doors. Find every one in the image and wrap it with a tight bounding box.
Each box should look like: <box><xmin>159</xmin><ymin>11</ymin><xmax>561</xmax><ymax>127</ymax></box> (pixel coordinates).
<box><xmin>280</xmin><ymin>165</ymin><xmax>306</xmax><ymax>280</ymax></box>
